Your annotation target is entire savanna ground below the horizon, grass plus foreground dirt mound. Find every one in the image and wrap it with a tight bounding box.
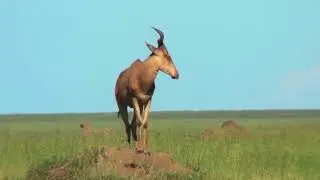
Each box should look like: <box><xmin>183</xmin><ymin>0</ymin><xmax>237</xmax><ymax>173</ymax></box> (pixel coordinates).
<box><xmin>0</xmin><ymin>110</ymin><xmax>320</xmax><ymax>180</ymax></box>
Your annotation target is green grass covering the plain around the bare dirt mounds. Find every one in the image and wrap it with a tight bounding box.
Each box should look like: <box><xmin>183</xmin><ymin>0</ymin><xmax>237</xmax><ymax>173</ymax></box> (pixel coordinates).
<box><xmin>0</xmin><ymin>111</ymin><xmax>320</xmax><ymax>180</ymax></box>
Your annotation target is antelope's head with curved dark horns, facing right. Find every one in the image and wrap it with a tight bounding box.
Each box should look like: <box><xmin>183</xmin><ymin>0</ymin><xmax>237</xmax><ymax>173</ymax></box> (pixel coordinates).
<box><xmin>146</xmin><ymin>27</ymin><xmax>179</xmax><ymax>79</ymax></box>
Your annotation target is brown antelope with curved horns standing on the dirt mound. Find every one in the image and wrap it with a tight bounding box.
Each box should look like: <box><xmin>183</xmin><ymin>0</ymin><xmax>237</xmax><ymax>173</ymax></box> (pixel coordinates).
<box><xmin>115</xmin><ymin>27</ymin><xmax>179</xmax><ymax>155</ymax></box>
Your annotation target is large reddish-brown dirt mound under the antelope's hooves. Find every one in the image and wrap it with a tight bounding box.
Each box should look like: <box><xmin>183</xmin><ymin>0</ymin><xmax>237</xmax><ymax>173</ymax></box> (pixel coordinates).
<box><xmin>27</xmin><ymin>146</ymin><xmax>191</xmax><ymax>180</ymax></box>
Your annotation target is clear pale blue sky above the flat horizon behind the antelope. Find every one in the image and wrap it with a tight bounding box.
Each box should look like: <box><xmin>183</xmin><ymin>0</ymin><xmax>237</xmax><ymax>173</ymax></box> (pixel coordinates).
<box><xmin>0</xmin><ymin>0</ymin><xmax>320</xmax><ymax>113</ymax></box>
